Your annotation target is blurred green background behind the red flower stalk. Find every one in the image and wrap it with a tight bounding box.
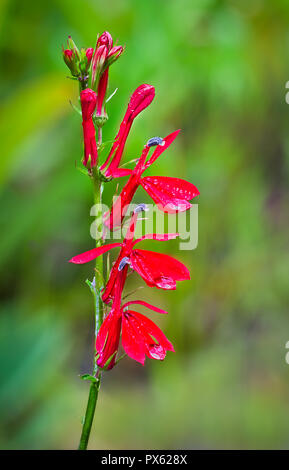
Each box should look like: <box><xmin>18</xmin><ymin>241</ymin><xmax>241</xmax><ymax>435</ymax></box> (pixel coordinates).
<box><xmin>0</xmin><ymin>0</ymin><xmax>289</xmax><ymax>449</ymax></box>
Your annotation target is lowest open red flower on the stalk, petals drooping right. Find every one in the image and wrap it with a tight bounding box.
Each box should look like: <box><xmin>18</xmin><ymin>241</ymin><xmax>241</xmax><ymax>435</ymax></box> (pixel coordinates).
<box><xmin>96</xmin><ymin>300</ymin><xmax>174</xmax><ymax>369</ymax></box>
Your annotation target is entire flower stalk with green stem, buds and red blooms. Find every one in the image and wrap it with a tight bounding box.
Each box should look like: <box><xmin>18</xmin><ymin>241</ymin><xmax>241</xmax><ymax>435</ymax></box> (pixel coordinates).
<box><xmin>62</xmin><ymin>31</ymin><xmax>199</xmax><ymax>450</ymax></box>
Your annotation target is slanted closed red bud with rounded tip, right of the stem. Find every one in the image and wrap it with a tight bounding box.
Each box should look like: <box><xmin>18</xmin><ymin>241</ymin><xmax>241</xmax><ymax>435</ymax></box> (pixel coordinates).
<box><xmin>100</xmin><ymin>84</ymin><xmax>155</xmax><ymax>178</ymax></box>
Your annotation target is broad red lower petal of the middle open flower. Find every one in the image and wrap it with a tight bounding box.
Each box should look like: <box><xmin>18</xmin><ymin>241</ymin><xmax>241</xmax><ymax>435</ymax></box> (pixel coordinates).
<box><xmin>130</xmin><ymin>250</ymin><xmax>190</xmax><ymax>290</ymax></box>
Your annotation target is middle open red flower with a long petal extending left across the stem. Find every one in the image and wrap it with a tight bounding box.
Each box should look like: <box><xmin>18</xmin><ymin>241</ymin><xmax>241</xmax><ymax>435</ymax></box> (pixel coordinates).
<box><xmin>70</xmin><ymin>205</ymin><xmax>190</xmax><ymax>303</ymax></box>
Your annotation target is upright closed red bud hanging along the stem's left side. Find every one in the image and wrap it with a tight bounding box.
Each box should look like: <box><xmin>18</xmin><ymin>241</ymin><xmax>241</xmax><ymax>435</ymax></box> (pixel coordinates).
<box><xmin>80</xmin><ymin>88</ymin><xmax>97</xmax><ymax>167</ymax></box>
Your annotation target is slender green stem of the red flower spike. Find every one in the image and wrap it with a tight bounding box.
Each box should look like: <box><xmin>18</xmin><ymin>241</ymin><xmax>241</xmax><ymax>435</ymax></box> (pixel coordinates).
<box><xmin>78</xmin><ymin>126</ymin><xmax>104</xmax><ymax>450</ymax></box>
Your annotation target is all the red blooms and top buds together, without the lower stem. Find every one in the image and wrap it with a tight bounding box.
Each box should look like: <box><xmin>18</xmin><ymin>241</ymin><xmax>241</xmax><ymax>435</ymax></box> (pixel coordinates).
<box><xmin>63</xmin><ymin>32</ymin><xmax>199</xmax><ymax>369</ymax></box>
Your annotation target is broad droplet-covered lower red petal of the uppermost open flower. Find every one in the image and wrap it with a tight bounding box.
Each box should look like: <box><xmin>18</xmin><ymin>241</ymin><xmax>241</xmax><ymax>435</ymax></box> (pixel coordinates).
<box><xmin>141</xmin><ymin>176</ymin><xmax>200</xmax><ymax>212</ymax></box>
